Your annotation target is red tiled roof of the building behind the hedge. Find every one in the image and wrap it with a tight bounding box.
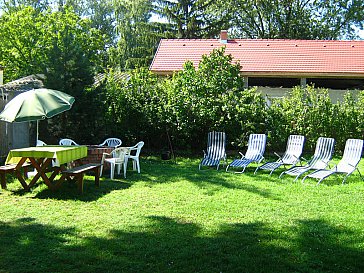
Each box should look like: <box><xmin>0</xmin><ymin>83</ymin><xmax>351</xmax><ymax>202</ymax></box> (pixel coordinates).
<box><xmin>150</xmin><ymin>39</ymin><xmax>364</xmax><ymax>78</ymax></box>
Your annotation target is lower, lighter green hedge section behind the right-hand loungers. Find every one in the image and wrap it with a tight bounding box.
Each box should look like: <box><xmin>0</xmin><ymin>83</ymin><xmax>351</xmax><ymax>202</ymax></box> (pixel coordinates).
<box><xmin>267</xmin><ymin>86</ymin><xmax>363</xmax><ymax>151</ymax></box>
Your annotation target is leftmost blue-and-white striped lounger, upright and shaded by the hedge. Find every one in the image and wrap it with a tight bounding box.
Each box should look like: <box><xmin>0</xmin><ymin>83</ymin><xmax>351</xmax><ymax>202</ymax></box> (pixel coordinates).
<box><xmin>198</xmin><ymin>131</ymin><xmax>226</xmax><ymax>170</ymax></box>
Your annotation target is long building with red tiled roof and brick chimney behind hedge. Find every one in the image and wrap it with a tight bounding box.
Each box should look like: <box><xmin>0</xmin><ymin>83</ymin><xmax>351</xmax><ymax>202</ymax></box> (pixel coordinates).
<box><xmin>150</xmin><ymin>31</ymin><xmax>364</xmax><ymax>100</ymax></box>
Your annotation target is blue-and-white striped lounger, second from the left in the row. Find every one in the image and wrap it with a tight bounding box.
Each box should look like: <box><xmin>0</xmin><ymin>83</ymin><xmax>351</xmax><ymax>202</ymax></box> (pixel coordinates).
<box><xmin>226</xmin><ymin>134</ymin><xmax>267</xmax><ymax>173</ymax></box>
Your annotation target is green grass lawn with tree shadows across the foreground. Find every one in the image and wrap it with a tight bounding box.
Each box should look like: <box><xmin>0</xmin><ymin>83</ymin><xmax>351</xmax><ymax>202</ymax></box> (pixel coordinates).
<box><xmin>0</xmin><ymin>158</ymin><xmax>364</xmax><ymax>272</ymax></box>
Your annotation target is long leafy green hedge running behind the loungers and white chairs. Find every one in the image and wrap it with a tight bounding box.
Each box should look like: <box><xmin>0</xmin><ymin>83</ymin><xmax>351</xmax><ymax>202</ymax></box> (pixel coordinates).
<box><xmin>100</xmin><ymin>48</ymin><xmax>364</xmax><ymax>152</ymax></box>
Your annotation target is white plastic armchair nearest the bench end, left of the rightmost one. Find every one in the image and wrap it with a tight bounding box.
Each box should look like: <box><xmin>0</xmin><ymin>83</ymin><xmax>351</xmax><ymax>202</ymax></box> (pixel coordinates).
<box><xmin>100</xmin><ymin>147</ymin><xmax>128</xmax><ymax>179</ymax></box>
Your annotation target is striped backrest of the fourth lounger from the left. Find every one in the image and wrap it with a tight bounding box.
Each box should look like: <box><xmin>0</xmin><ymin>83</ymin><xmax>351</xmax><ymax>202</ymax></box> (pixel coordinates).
<box><xmin>309</xmin><ymin>137</ymin><xmax>335</xmax><ymax>169</ymax></box>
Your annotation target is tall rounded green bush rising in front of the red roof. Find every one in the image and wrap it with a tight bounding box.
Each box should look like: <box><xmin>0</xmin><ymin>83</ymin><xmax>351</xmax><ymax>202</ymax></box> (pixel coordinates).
<box><xmin>161</xmin><ymin>48</ymin><xmax>265</xmax><ymax>149</ymax></box>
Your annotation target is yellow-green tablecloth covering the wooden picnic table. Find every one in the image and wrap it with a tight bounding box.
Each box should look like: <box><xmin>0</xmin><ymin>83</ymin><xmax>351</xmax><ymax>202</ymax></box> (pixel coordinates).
<box><xmin>6</xmin><ymin>145</ymin><xmax>87</xmax><ymax>164</ymax></box>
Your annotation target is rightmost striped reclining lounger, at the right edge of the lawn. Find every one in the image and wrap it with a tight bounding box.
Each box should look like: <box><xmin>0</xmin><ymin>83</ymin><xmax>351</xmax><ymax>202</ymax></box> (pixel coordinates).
<box><xmin>302</xmin><ymin>139</ymin><xmax>364</xmax><ymax>185</ymax></box>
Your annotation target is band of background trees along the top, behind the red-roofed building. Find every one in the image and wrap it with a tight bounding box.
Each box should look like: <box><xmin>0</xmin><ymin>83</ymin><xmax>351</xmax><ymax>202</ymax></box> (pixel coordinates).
<box><xmin>0</xmin><ymin>0</ymin><xmax>364</xmax><ymax>76</ymax></box>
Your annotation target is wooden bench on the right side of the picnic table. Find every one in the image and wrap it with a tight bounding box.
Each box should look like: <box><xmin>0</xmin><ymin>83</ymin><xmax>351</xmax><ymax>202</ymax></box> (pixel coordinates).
<box><xmin>58</xmin><ymin>163</ymin><xmax>101</xmax><ymax>194</ymax></box>
